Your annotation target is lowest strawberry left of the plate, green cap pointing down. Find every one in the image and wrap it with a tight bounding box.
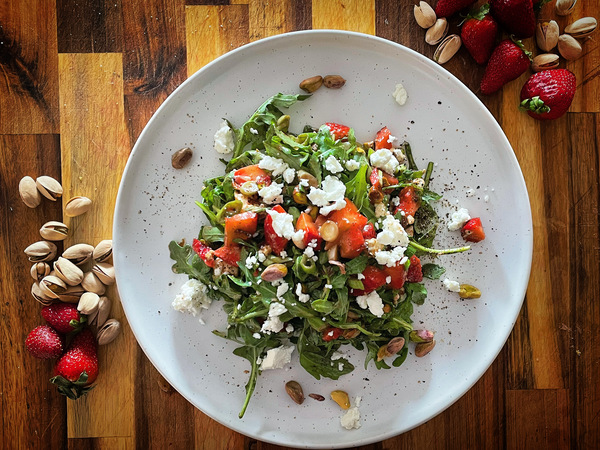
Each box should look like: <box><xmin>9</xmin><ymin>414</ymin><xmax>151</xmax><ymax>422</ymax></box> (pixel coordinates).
<box><xmin>50</xmin><ymin>328</ymin><xmax>98</xmax><ymax>400</ymax></box>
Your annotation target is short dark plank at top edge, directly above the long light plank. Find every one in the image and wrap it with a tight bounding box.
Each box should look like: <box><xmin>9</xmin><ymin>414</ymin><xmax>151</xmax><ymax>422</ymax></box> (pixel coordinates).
<box><xmin>56</xmin><ymin>0</ymin><xmax>123</xmax><ymax>53</ymax></box>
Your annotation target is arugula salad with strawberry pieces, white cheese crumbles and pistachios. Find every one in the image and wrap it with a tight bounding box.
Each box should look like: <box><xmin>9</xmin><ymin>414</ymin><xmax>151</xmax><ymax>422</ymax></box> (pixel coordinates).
<box><xmin>169</xmin><ymin>94</ymin><xmax>485</xmax><ymax>418</ymax></box>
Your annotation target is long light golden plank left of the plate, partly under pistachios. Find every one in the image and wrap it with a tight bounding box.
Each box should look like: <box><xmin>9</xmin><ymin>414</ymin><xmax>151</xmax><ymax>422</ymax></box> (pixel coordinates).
<box><xmin>59</xmin><ymin>53</ymin><xmax>135</xmax><ymax>438</ymax></box>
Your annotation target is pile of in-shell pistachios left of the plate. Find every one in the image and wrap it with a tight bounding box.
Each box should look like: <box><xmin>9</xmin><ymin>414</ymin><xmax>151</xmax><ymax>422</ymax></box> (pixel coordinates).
<box><xmin>19</xmin><ymin>176</ymin><xmax>121</xmax><ymax>345</ymax></box>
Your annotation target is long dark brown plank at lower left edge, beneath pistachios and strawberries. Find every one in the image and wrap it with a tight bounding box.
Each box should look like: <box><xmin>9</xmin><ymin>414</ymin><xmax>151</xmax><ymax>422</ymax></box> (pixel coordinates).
<box><xmin>0</xmin><ymin>135</ymin><xmax>67</xmax><ymax>448</ymax></box>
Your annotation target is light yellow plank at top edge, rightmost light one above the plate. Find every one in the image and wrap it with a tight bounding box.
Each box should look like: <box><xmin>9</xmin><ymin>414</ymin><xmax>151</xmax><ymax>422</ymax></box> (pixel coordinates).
<box><xmin>312</xmin><ymin>0</ymin><xmax>375</xmax><ymax>34</ymax></box>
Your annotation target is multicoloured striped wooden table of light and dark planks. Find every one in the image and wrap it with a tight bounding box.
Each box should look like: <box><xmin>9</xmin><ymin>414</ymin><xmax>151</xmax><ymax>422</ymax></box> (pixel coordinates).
<box><xmin>0</xmin><ymin>0</ymin><xmax>600</xmax><ymax>449</ymax></box>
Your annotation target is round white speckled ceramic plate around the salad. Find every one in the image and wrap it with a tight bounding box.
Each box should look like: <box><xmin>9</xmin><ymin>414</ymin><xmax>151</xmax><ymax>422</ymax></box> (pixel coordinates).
<box><xmin>114</xmin><ymin>31</ymin><xmax>532</xmax><ymax>447</ymax></box>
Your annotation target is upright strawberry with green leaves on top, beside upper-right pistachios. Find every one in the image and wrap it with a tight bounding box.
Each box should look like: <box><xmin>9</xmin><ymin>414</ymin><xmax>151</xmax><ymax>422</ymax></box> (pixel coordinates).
<box><xmin>460</xmin><ymin>3</ymin><xmax>498</xmax><ymax>65</ymax></box>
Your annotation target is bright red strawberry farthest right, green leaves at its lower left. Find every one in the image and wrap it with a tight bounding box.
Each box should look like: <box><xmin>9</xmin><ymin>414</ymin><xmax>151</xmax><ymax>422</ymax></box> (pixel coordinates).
<box><xmin>521</xmin><ymin>69</ymin><xmax>577</xmax><ymax>120</ymax></box>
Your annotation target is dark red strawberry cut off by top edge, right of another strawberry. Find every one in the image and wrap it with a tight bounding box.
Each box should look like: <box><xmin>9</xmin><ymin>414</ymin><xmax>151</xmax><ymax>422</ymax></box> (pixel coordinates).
<box><xmin>490</xmin><ymin>0</ymin><xmax>535</xmax><ymax>38</ymax></box>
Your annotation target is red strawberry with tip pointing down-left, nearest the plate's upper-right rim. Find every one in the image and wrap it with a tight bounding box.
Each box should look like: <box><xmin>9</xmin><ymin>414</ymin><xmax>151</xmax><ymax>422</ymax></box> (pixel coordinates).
<box><xmin>481</xmin><ymin>39</ymin><xmax>531</xmax><ymax>94</ymax></box>
